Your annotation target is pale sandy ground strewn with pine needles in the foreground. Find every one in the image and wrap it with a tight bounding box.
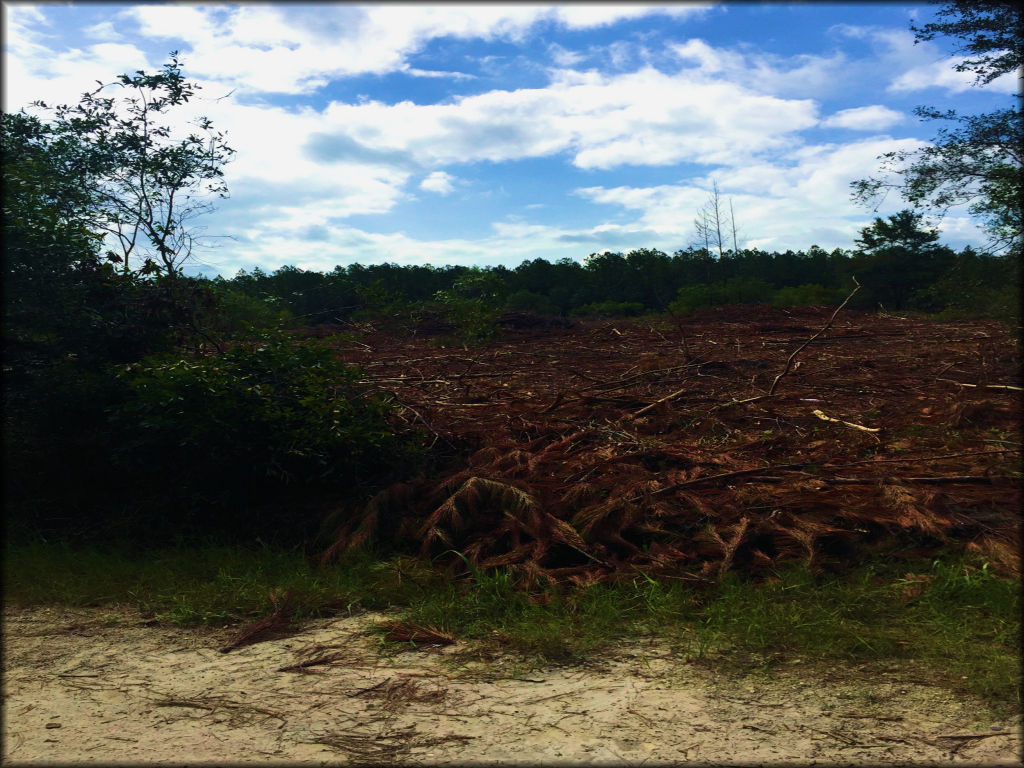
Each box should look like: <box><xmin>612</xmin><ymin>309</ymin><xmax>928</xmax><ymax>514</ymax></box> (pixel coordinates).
<box><xmin>2</xmin><ymin>608</ymin><xmax>1021</xmax><ymax>765</ymax></box>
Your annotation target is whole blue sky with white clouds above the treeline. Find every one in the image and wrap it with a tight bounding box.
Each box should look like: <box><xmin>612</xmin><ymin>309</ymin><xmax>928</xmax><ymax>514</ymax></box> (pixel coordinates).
<box><xmin>3</xmin><ymin>2</ymin><xmax>1017</xmax><ymax>278</ymax></box>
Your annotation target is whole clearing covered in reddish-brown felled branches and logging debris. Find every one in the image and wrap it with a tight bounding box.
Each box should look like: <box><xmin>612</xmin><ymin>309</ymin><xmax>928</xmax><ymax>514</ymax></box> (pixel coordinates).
<box><xmin>325</xmin><ymin>307</ymin><xmax>1021</xmax><ymax>585</ymax></box>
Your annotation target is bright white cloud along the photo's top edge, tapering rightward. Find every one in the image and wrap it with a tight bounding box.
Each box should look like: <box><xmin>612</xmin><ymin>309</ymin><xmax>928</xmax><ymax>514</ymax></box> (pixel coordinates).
<box><xmin>116</xmin><ymin>3</ymin><xmax>709</xmax><ymax>93</ymax></box>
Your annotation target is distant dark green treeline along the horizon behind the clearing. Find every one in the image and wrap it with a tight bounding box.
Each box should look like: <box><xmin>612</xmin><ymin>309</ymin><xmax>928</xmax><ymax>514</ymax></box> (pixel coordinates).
<box><xmin>212</xmin><ymin>219</ymin><xmax>1020</xmax><ymax>333</ymax></box>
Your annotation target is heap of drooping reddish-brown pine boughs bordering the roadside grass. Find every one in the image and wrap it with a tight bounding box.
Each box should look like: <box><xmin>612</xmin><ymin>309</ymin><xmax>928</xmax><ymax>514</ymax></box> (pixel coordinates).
<box><xmin>327</xmin><ymin>429</ymin><xmax>1019</xmax><ymax>584</ymax></box>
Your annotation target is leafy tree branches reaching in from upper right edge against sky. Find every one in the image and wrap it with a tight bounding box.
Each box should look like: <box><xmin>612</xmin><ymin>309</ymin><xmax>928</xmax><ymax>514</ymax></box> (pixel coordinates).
<box><xmin>852</xmin><ymin>0</ymin><xmax>1024</xmax><ymax>251</ymax></box>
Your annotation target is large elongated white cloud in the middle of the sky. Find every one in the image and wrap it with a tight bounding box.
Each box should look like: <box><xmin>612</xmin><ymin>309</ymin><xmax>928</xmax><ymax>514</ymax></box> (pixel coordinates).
<box><xmin>315</xmin><ymin>68</ymin><xmax>817</xmax><ymax>168</ymax></box>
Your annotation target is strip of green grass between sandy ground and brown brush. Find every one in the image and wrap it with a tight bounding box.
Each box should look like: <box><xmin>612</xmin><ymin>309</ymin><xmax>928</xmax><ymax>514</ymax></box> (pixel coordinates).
<box><xmin>4</xmin><ymin>543</ymin><xmax>1021</xmax><ymax>708</ymax></box>
